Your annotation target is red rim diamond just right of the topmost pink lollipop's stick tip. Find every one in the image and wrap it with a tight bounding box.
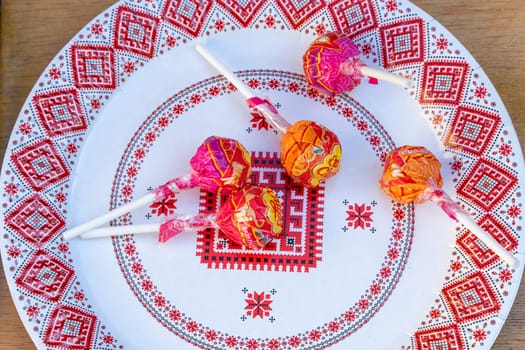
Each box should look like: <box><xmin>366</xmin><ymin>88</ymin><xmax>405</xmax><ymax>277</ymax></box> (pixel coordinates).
<box><xmin>419</xmin><ymin>61</ymin><xmax>469</xmax><ymax>105</ymax></box>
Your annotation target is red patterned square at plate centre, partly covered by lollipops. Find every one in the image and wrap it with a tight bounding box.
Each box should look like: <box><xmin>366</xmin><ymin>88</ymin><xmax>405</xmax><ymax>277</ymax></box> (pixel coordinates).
<box><xmin>197</xmin><ymin>152</ymin><xmax>324</xmax><ymax>272</ymax></box>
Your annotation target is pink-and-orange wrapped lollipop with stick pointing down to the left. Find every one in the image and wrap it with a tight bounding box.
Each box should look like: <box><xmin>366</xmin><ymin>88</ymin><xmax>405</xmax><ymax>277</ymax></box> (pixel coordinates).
<box><xmin>63</xmin><ymin>136</ymin><xmax>251</xmax><ymax>240</ymax></box>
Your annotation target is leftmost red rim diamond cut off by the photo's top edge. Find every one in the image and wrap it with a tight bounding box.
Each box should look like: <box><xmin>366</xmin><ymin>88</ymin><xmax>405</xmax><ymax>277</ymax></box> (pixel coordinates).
<box><xmin>163</xmin><ymin>0</ymin><xmax>212</xmax><ymax>37</ymax></box>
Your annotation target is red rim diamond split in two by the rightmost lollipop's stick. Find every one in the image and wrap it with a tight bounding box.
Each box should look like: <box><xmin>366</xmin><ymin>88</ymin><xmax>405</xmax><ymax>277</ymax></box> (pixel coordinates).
<box><xmin>457</xmin><ymin>214</ymin><xmax>518</xmax><ymax>269</ymax></box>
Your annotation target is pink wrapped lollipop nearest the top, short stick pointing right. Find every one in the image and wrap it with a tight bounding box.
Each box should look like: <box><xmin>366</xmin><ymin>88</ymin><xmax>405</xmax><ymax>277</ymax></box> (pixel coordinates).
<box><xmin>303</xmin><ymin>32</ymin><xmax>412</xmax><ymax>95</ymax></box>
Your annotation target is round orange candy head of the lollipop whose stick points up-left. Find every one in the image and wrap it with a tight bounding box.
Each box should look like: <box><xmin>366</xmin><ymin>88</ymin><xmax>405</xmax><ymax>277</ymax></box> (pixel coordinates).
<box><xmin>281</xmin><ymin>120</ymin><xmax>342</xmax><ymax>187</ymax></box>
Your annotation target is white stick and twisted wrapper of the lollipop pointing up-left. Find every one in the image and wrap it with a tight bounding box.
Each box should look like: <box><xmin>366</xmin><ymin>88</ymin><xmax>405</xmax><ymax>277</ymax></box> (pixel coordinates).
<box><xmin>195</xmin><ymin>44</ymin><xmax>290</xmax><ymax>134</ymax></box>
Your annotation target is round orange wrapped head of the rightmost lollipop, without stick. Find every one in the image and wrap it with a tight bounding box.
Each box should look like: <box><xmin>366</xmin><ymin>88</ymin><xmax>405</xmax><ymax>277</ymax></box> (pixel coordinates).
<box><xmin>379</xmin><ymin>146</ymin><xmax>443</xmax><ymax>204</ymax></box>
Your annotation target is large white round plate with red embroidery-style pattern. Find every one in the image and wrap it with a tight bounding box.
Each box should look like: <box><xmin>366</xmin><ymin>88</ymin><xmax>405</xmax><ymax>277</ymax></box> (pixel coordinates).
<box><xmin>1</xmin><ymin>0</ymin><xmax>524</xmax><ymax>350</ymax></box>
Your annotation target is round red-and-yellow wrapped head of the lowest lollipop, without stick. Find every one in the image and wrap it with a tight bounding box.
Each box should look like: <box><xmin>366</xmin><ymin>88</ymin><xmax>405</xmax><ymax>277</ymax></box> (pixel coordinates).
<box><xmin>216</xmin><ymin>186</ymin><xmax>283</xmax><ymax>249</ymax></box>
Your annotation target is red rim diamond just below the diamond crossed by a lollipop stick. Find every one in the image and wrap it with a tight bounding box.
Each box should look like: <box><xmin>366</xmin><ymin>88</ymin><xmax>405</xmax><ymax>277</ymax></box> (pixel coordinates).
<box><xmin>442</xmin><ymin>271</ymin><xmax>501</xmax><ymax>323</ymax></box>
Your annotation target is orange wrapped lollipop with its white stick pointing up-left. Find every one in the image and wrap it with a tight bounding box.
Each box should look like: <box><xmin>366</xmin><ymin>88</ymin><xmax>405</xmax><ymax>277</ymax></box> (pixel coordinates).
<box><xmin>195</xmin><ymin>45</ymin><xmax>342</xmax><ymax>187</ymax></box>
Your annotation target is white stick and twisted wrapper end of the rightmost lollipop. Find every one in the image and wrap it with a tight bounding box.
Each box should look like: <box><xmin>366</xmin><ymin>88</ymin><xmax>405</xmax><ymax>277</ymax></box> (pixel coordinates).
<box><xmin>426</xmin><ymin>186</ymin><xmax>519</xmax><ymax>267</ymax></box>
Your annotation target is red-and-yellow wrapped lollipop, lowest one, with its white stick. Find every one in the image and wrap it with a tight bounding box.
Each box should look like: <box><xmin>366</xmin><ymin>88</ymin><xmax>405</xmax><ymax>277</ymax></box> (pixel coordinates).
<box><xmin>81</xmin><ymin>186</ymin><xmax>283</xmax><ymax>249</ymax></box>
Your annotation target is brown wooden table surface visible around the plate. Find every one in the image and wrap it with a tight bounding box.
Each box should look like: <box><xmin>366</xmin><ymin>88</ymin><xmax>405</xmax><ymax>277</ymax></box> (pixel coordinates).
<box><xmin>0</xmin><ymin>0</ymin><xmax>525</xmax><ymax>350</ymax></box>
